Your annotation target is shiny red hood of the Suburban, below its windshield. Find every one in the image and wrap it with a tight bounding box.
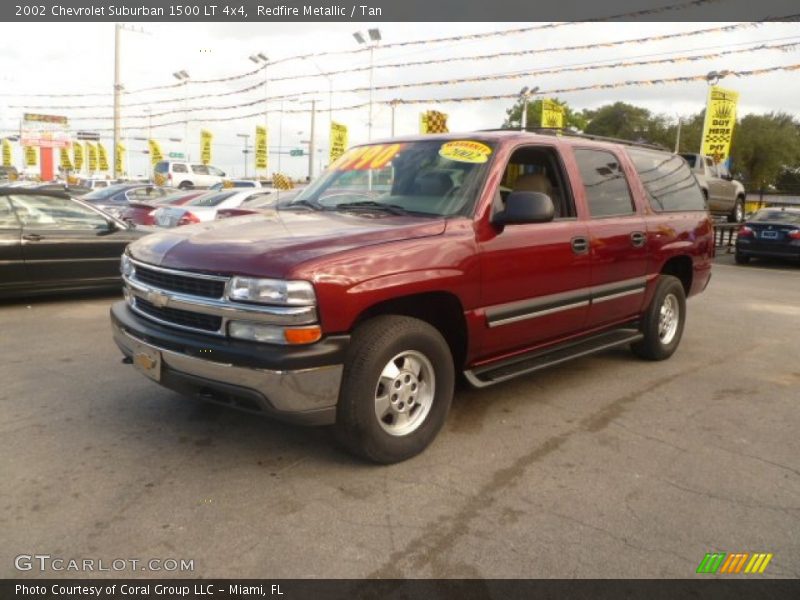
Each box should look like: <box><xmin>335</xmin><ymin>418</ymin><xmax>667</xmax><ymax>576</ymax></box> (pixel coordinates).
<box><xmin>130</xmin><ymin>210</ymin><xmax>445</xmax><ymax>277</ymax></box>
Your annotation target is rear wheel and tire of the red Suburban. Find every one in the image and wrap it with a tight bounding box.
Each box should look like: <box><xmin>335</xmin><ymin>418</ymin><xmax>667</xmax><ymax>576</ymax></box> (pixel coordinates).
<box><xmin>631</xmin><ymin>275</ymin><xmax>686</xmax><ymax>360</ymax></box>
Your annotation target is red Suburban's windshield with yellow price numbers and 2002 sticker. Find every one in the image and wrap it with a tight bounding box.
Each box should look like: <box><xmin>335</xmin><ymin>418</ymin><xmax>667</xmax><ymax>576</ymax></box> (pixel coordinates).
<box><xmin>288</xmin><ymin>140</ymin><xmax>493</xmax><ymax>216</ymax></box>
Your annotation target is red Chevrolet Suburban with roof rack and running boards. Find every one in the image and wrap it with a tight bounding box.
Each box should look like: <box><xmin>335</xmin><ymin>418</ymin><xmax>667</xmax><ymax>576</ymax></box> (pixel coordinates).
<box><xmin>111</xmin><ymin>131</ymin><xmax>714</xmax><ymax>463</ymax></box>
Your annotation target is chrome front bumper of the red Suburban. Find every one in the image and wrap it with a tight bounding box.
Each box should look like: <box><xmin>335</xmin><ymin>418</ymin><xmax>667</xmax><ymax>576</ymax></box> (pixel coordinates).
<box><xmin>112</xmin><ymin>319</ymin><xmax>343</xmax><ymax>425</ymax></box>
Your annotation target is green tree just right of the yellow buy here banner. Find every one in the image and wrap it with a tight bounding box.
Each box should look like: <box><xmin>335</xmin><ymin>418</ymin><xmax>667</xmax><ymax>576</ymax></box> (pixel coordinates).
<box><xmin>731</xmin><ymin>113</ymin><xmax>800</xmax><ymax>189</ymax></box>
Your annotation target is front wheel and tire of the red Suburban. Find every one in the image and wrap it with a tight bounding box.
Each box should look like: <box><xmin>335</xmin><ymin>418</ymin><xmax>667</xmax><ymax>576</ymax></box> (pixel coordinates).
<box><xmin>334</xmin><ymin>315</ymin><xmax>455</xmax><ymax>464</ymax></box>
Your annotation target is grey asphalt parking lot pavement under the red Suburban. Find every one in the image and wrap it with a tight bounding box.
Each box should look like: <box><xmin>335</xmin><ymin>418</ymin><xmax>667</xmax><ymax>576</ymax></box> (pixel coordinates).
<box><xmin>0</xmin><ymin>255</ymin><xmax>800</xmax><ymax>578</ymax></box>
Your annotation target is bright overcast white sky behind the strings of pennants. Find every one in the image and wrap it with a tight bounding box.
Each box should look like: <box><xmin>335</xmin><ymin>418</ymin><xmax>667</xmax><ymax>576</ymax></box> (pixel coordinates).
<box><xmin>0</xmin><ymin>22</ymin><xmax>800</xmax><ymax>177</ymax></box>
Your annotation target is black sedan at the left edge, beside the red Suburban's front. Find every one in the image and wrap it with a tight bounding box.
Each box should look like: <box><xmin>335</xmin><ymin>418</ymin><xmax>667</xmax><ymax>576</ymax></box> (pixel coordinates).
<box><xmin>0</xmin><ymin>187</ymin><xmax>145</xmax><ymax>297</ymax></box>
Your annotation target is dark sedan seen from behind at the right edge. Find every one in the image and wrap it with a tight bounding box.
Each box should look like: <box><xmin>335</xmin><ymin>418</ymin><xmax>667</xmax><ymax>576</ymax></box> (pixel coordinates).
<box><xmin>736</xmin><ymin>208</ymin><xmax>800</xmax><ymax>265</ymax></box>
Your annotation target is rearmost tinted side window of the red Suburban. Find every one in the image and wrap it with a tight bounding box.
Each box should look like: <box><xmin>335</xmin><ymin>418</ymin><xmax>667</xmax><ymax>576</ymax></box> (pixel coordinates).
<box><xmin>628</xmin><ymin>148</ymin><xmax>706</xmax><ymax>212</ymax></box>
